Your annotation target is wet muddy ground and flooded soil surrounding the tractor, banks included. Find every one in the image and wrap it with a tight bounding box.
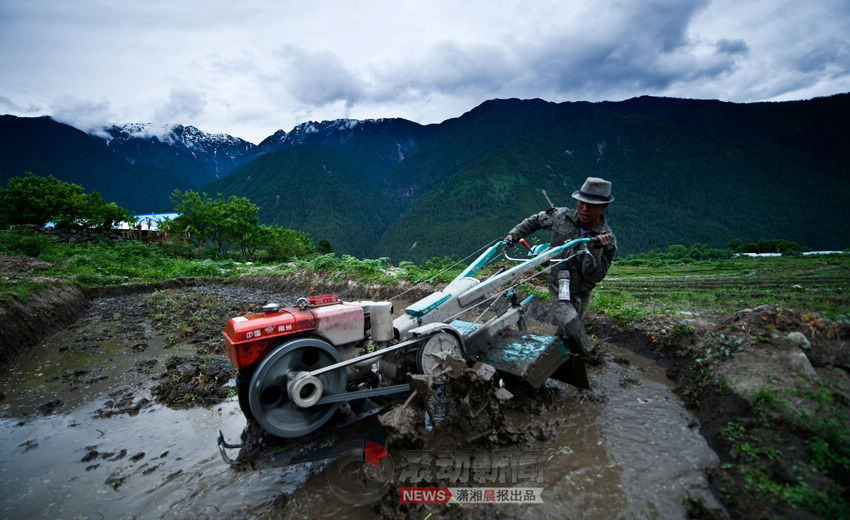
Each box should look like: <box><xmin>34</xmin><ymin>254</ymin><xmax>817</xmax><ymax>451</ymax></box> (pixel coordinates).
<box><xmin>0</xmin><ymin>264</ymin><xmax>850</xmax><ymax>518</ymax></box>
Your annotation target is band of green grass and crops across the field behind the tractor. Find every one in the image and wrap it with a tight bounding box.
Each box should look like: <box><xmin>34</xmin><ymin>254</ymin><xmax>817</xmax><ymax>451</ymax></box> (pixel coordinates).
<box><xmin>0</xmin><ymin>221</ymin><xmax>850</xmax><ymax>322</ymax></box>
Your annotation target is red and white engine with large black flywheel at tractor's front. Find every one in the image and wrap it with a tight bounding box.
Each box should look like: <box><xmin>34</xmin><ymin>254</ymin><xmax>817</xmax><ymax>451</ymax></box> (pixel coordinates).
<box><xmin>223</xmin><ymin>295</ymin><xmax>397</xmax><ymax>437</ymax></box>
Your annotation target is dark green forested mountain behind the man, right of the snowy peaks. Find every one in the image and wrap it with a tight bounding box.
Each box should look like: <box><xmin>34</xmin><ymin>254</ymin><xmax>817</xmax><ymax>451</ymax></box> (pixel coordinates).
<box><xmin>208</xmin><ymin>95</ymin><xmax>850</xmax><ymax>260</ymax></box>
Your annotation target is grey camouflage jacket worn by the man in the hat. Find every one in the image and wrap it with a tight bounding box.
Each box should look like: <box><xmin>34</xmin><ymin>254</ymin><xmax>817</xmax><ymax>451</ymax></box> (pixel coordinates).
<box><xmin>508</xmin><ymin>208</ymin><xmax>617</xmax><ymax>297</ymax></box>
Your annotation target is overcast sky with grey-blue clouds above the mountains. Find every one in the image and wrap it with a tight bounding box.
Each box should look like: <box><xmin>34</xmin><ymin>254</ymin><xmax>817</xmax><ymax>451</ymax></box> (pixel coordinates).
<box><xmin>0</xmin><ymin>0</ymin><xmax>850</xmax><ymax>143</ymax></box>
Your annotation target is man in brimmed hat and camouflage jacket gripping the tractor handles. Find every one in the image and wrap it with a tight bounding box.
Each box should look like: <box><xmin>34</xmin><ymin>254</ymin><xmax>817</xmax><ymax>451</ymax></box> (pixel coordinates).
<box><xmin>505</xmin><ymin>177</ymin><xmax>617</xmax><ymax>357</ymax></box>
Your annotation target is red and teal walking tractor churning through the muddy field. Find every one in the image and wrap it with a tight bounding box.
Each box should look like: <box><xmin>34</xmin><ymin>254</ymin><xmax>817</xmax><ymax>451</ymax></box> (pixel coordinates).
<box><xmin>219</xmin><ymin>238</ymin><xmax>597</xmax><ymax>447</ymax></box>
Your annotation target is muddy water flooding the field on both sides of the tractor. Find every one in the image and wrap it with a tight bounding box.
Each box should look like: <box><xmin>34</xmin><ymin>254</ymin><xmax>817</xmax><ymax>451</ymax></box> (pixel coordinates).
<box><xmin>0</xmin><ymin>290</ymin><xmax>717</xmax><ymax>518</ymax></box>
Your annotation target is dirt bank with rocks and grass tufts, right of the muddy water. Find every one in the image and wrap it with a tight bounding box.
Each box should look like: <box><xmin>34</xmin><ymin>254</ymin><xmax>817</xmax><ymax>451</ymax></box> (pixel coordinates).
<box><xmin>591</xmin><ymin>306</ymin><xmax>850</xmax><ymax>518</ymax></box>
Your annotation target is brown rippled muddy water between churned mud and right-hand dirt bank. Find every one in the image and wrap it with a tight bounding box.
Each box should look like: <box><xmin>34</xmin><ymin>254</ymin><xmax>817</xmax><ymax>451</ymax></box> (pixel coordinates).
<box><xmin>540</xmin><ymin>345</ymin><xmax>720</xmax><ymax>518</ymax></box>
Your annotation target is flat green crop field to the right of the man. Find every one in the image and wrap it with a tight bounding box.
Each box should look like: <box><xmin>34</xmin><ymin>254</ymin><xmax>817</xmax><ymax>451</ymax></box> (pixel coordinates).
<box><xmin>591</xmin><ymin>249</ymin><xmax>850</xmax><ymax>319</ymax></box>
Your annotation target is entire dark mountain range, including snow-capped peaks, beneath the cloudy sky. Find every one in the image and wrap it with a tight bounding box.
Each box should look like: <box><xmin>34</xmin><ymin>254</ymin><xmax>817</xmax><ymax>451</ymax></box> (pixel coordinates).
<box><xmin>0</xmin><ymin>94</ymin><xmax>850</xmax><ymax>261</ymax></box>
